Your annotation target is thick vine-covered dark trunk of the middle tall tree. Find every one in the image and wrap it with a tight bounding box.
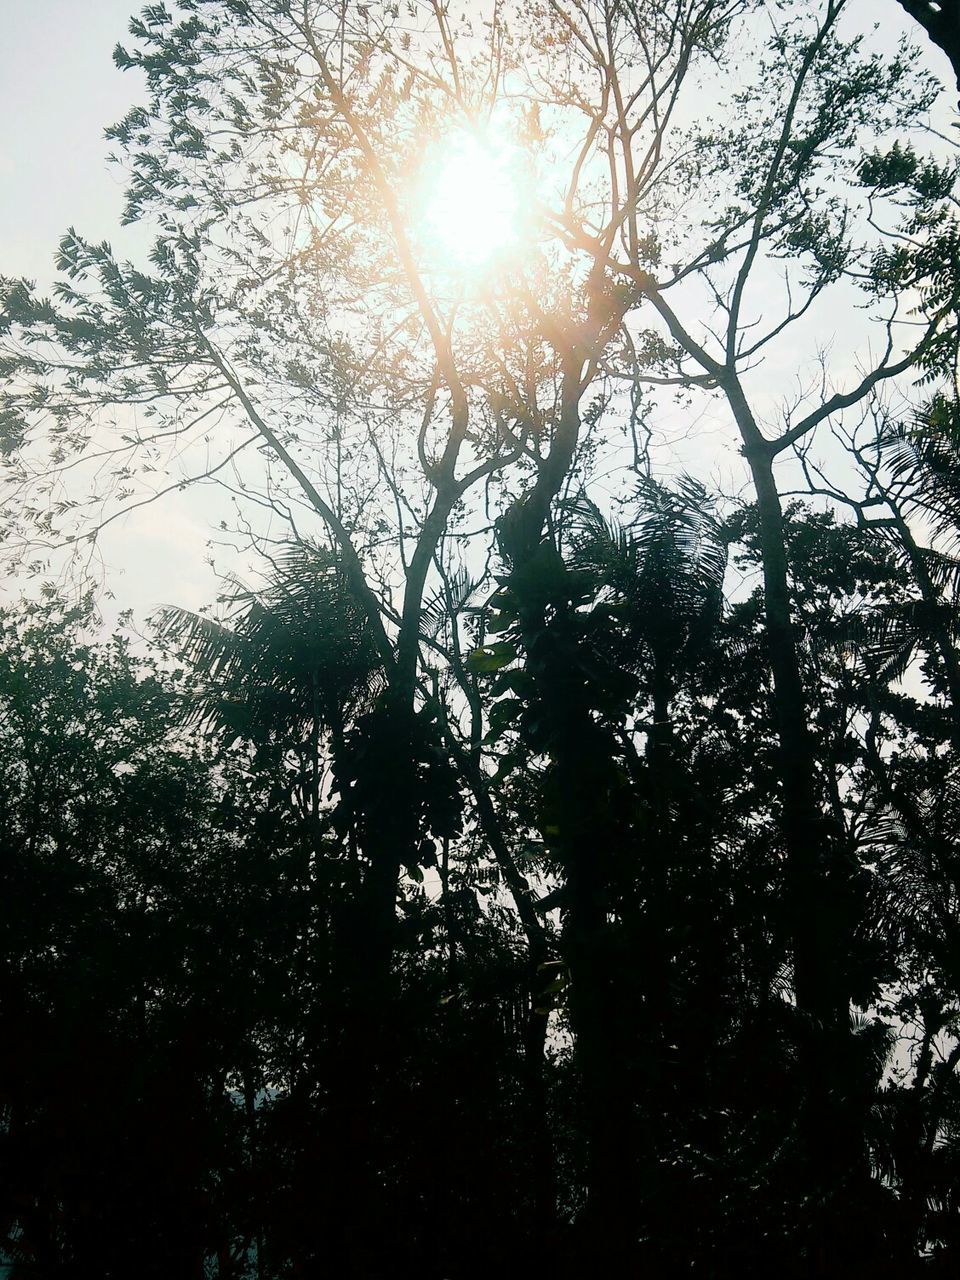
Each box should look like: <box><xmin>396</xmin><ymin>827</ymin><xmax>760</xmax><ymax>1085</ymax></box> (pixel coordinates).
<box><xmin>500</xmin><ymin>351</ymin><xmax>639</xmax><ymax>1274</ymax></box>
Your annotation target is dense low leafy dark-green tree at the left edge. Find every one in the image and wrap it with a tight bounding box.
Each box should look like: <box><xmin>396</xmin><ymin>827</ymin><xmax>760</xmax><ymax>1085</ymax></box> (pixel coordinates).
<box><xmin>0</xmin><ymin>600</ymin><xmax>265</xmax><ymax>1276</ymax></box>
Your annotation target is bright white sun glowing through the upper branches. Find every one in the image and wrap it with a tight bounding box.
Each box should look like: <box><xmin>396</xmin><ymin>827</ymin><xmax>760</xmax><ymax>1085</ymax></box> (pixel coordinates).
<box><xmin>416</xmin><ymin>128</ymin><xmax>529</xmax><ymax>274</ymax></box>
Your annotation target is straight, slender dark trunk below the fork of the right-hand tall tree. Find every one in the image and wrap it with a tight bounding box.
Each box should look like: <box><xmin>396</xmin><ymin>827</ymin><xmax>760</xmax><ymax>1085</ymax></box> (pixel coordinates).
<box><xmin>741</xmin><ymin>426</ymin><xmax>869</xmax><ymax>1276</ymax></box>
